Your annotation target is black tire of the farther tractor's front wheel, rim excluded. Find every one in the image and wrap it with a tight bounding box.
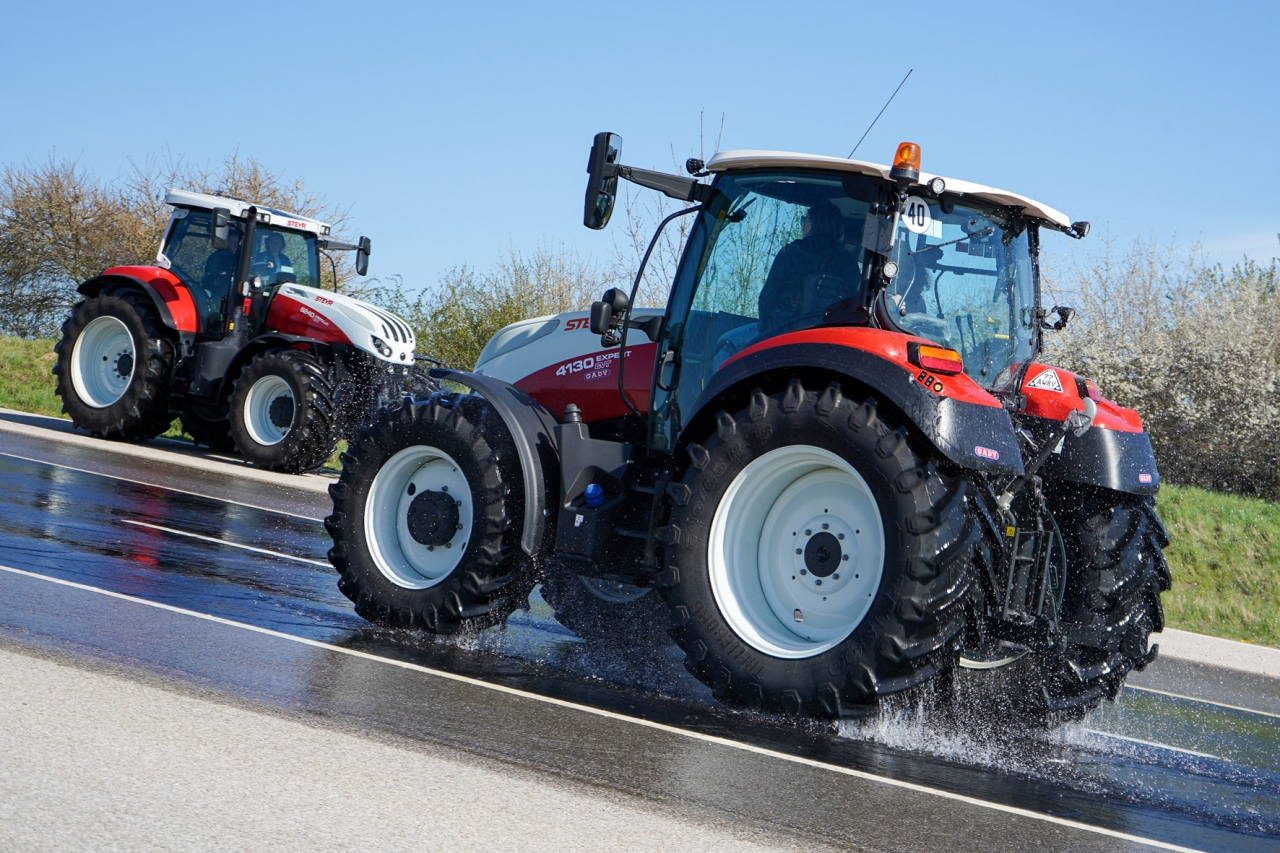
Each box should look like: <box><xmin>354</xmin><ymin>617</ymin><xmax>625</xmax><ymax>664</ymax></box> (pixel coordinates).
<box><xmin>230</xmin><ymin>350</ymin><xmax>339</xmax><ymax>474</ymax></box>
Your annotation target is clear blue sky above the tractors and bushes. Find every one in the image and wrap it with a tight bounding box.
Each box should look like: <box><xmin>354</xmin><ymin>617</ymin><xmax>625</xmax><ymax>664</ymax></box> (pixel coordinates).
<box><xmin>0</xmin><ymin>0</ymin><xmax>1280</xmax><ymax>287</ymax></box>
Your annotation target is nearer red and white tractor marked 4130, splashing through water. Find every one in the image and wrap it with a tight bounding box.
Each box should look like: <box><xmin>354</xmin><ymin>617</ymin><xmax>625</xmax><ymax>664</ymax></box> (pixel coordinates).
<box><xmin>326</xmin><ymin>133</ymin><xmax>1170</xmax><ymax>721</ymax></box>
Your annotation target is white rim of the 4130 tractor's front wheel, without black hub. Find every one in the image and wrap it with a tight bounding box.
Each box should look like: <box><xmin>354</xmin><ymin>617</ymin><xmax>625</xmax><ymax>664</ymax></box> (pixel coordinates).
<box><xmin>365</xmin><ymin>446</ymin><xmax>472</xmax><ymax>589</ymax></box>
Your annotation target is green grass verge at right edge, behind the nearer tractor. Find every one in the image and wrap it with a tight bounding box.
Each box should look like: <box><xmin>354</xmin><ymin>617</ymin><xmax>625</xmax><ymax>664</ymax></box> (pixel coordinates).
<box><xmin>1156</xmin><ymin>485</ymin><xmax>1280</xmax><ymax>647</ymax></box>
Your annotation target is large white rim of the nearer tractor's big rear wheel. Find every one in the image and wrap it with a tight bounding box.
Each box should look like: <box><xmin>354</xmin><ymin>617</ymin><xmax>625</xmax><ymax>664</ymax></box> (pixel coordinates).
<box><xmin>708</xmin><ymin>444</ymin><xmax>884</xmax><ymax>660</ymax></box>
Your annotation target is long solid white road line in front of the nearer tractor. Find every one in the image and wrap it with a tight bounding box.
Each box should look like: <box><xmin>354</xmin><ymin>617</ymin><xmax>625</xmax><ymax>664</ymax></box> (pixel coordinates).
<box><xmin>0</xmin><ymin>565</ymin><xmax>1203</xmax><ymax>853</ymax></box>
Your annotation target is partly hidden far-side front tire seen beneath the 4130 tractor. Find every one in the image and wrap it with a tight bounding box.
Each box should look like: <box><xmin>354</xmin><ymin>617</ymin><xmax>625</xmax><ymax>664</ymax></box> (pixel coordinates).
<box><xmin>543</xmin><ymin>566</ymin><xmax>671</xmax><ymax>651</ymax></box>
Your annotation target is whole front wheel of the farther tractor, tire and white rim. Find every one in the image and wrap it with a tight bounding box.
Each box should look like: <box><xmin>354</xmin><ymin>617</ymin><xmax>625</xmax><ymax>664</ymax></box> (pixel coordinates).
<box><xmin>230</xmin><ymin>350</ymin><xmax>338</xmax><ymax>474</ymax></box>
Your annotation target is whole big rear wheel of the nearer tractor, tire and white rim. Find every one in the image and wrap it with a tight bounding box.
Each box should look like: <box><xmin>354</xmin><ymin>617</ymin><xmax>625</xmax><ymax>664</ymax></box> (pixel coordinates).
<box><xmin>657</xmin><ymin>380</ymin><xmax>978</xmax><ymax>716</ymax></box>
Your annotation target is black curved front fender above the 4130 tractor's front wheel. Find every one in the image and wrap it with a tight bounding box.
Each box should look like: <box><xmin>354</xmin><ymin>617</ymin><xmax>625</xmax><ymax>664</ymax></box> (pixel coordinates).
<box><xmin>431</xmin><ymin>370</ymin><xmax>559</xmax><ymax>556</ymax></box>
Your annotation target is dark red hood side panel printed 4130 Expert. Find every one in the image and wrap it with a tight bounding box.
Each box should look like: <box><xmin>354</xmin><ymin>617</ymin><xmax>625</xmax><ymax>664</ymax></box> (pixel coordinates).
<box><xmin>516</xmin><ymin>342</ymin><xmax>658</xmax><ymax>423</ymax></box>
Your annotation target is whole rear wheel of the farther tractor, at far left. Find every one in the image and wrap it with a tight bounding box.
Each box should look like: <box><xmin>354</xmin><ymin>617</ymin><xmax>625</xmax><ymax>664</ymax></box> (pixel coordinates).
<box><xmin>54</xmin><ymin>292</ymin><xmax>174</xmax><ymax>441</ymax></box>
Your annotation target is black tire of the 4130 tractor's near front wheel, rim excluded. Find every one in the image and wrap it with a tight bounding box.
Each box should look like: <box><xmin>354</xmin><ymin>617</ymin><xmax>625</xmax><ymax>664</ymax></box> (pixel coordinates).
<box><xmin>325</xmin><ymin>396</ymin><xmax>536</xmax><ymax>634</ymax></box>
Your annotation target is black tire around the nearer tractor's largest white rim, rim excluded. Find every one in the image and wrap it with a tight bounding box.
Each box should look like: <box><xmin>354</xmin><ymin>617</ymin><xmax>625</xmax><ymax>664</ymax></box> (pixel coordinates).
<box><xmin>655</xmin><ymin>379</ymin><xmax>978</xmax><ymax>716</ymax></box>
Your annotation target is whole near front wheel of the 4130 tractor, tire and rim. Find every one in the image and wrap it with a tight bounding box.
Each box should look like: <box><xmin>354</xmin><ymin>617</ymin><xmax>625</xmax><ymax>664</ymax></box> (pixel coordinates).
<box><xmin>325</xmin><ymin>397</ymin><xmax>535</xmax><ymax>634</ymax></box>
